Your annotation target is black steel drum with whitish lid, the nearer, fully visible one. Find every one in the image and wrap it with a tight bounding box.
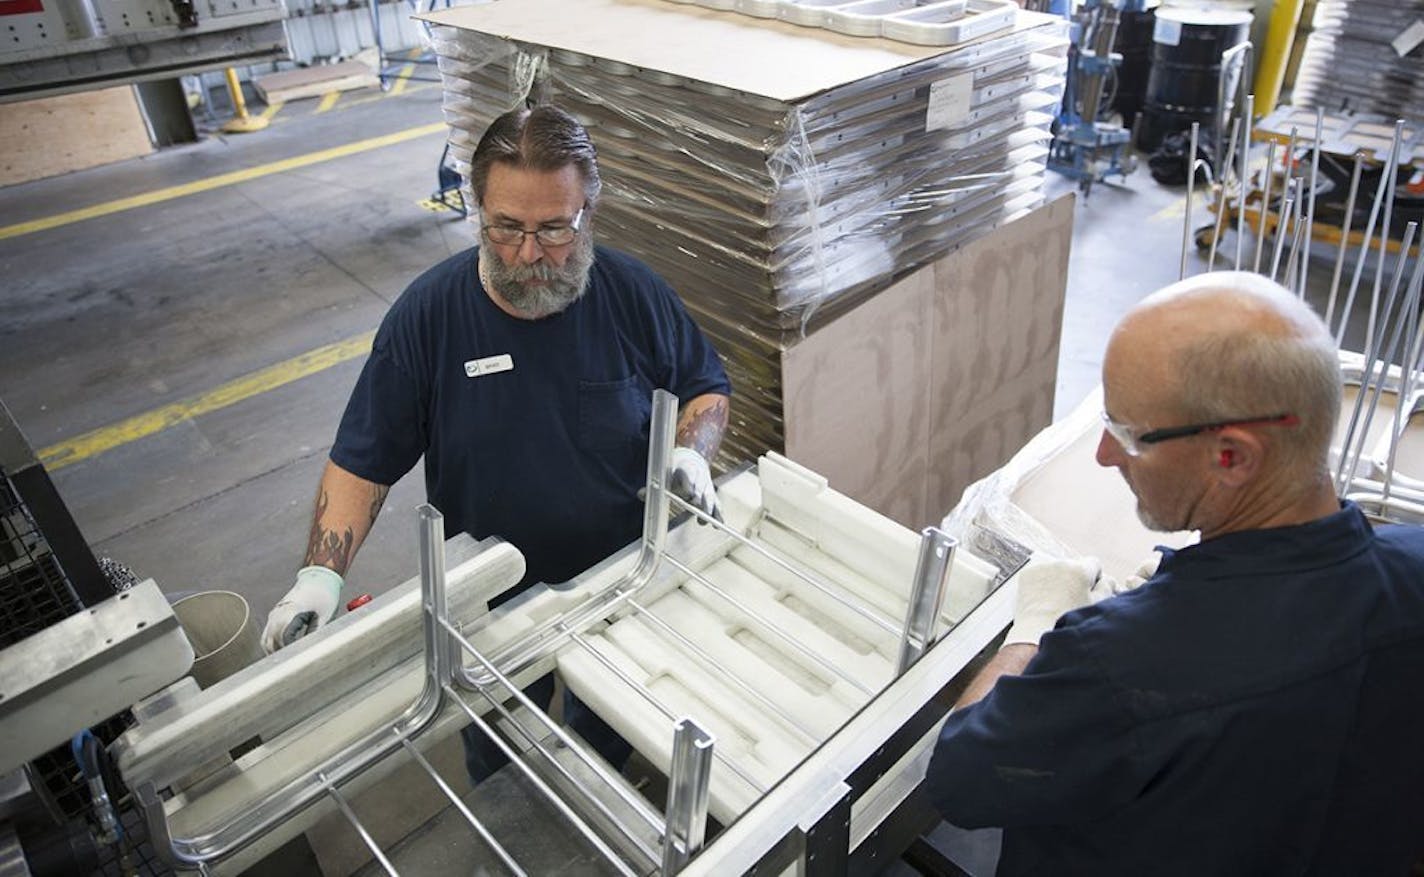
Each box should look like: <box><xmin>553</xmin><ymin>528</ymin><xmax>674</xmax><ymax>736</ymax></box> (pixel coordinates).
<box><xmin>1138</xmin><ymin>7</ymin><xmax>1252</xmax><ymax>152</ymax></box>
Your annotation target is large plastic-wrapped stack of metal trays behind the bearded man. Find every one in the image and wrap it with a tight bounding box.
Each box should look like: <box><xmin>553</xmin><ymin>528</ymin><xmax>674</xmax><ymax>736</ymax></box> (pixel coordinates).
<box><xmin>433</xmin><ymin>17</ymin><xmax>1067</xmax><ymax>466</ymax></box>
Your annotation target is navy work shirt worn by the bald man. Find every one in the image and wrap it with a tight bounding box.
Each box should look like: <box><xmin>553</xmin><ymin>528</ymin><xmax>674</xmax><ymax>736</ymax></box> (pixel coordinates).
<box><xmin>927</xmin><ymin>504</ymin><xmax>1424</xmax><ymax>877</ymax></box>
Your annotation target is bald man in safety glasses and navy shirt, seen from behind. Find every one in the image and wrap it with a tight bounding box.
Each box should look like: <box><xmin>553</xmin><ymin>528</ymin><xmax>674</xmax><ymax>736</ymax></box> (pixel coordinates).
<box><xmin>927</xmin><ymin>272</ymin><xmax>1424</xmax><ymax>877</ymax></box>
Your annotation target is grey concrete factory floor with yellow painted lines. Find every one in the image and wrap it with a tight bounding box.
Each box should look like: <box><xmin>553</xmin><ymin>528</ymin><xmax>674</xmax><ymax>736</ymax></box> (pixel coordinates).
<box><xmin>0</xmin><ymin>81</ymin><xmax>1384</xmax><ymax>871</ymax></box>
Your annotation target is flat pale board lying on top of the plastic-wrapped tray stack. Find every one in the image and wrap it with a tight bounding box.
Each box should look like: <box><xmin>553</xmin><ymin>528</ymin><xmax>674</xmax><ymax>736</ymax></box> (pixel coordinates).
<box><xmin>420</xmin><ymin>0</ymin><xmax>1049</xmax><ymax>103</ymax></box>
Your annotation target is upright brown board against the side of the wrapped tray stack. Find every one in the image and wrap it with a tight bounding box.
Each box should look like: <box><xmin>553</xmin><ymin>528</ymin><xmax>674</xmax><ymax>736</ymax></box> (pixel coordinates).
<box><xmin>782</xmin><ymin>195</ymin><xmax>1074</xmax><ymax>530</ymax></box>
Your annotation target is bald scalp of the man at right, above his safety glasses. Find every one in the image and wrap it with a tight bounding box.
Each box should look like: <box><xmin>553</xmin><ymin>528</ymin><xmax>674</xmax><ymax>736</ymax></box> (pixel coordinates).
<box><xmin>1105</xmin><ymin>272</ymin><xmax>1340</xmax><ymax>468</ymax></box>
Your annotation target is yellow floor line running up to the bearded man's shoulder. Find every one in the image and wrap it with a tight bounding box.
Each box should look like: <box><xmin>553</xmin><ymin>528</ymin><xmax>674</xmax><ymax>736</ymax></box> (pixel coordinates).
<box><xmin>40</xmin><ymin>332</ymin><xmax>376</xmax><ymax>470</ymax></box>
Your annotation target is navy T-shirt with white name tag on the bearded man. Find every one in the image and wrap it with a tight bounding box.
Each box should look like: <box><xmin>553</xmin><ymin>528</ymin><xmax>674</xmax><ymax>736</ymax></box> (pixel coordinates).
<box><xmin>330</xmin><ymin>246</ymin><xmax>731</xmax><ymax>587</ymax></box>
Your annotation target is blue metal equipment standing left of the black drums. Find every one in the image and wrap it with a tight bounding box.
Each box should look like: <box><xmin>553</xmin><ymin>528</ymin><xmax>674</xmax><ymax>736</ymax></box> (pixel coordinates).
<box><xmin>1048</xmin><ymin>0</ymin><xmax>1146</xmax><ymax>198</ymax></box>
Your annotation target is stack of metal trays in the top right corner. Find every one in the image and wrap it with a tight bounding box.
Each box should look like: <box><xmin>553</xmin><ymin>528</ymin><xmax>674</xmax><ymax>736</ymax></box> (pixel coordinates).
<box><xmin>1292</xmin><ymin>0</ymin><xmax>1424</xmax><ymax>120</ymax></box>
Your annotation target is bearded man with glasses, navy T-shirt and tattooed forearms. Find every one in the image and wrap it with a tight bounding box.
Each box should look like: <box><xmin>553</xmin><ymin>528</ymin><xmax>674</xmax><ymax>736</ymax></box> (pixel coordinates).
<box><xmin>263</xmin><ymin>105</ymin><xmax>731</xmax><ymax>782</ymax></box>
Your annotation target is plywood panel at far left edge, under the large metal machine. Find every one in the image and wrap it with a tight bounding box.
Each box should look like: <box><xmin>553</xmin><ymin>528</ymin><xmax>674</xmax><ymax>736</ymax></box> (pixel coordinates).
<box><xmin>0</xmin><ymin>85</ymin><xmax>154</xmax><ymax>185</ymax></box>
